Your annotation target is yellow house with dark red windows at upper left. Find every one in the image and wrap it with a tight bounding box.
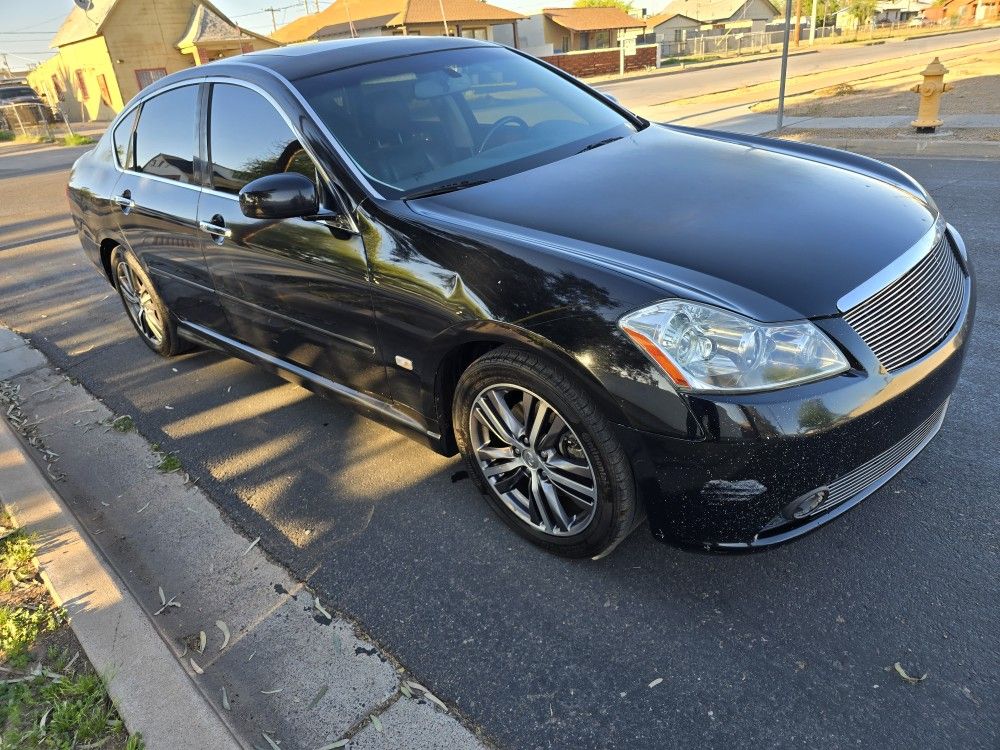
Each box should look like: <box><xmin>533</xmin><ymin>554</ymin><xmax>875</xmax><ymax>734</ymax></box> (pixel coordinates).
<box><xmin>28</xmin><ymin>0</ymin><xmax>278</xmax><ymax>121</ymax></box>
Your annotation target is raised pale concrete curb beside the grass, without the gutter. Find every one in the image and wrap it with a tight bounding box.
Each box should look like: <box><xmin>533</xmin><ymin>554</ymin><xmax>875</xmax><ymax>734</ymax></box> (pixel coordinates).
<box><xmin>0</xmin><ymin>400</ymin><xmax>244</xmax><ymax>750</ymax></box>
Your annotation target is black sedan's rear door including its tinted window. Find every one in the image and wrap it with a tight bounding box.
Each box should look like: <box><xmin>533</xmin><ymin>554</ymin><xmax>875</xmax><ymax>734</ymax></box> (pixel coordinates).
<box><xmin>113</xmin><ymin>85</ymin><xmax>228</xmax><ymax>332</ymax></box>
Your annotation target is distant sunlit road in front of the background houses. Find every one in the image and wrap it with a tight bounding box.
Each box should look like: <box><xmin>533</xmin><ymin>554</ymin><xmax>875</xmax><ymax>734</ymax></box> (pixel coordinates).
<box><xmin>597</xmin><ymin>28</ymin><xmax>1000</xmax><ymax>109</ymax></box>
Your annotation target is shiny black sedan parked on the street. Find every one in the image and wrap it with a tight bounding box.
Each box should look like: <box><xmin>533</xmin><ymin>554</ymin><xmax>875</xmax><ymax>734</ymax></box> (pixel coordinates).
<box><xmin>69</xmin><ymin>37</ymin><xmax>974</xmax><ymax>557</ymax></box>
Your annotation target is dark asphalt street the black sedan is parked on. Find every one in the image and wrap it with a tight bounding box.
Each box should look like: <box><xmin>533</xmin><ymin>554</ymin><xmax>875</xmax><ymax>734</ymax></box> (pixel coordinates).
<box><xmin>0</xmin><ymin>144</ymin><xmax>1000</xmax><ymax>750</ymax></box>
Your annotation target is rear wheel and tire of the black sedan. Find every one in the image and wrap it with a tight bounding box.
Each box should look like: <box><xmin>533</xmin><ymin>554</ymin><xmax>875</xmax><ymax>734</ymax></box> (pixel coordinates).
<box><xmin>111</xmin><ymin>246</ymin><xmax>192</xmax><ymax>357</ymax></box>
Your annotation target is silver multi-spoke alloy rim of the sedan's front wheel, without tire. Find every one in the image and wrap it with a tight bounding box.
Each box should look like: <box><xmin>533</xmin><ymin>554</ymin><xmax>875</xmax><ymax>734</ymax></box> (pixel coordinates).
<box><xmin>469</xmin><ymin>384</ymin><xmax>597</xmax><ymax>536</ymax></box>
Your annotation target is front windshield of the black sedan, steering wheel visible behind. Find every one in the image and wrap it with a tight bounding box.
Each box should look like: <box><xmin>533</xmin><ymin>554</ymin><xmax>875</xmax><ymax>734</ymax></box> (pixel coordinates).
<box><xmin>296</xmin><ymin>47</ymin><xmax>637</xmax><ymax>198</ymax></box>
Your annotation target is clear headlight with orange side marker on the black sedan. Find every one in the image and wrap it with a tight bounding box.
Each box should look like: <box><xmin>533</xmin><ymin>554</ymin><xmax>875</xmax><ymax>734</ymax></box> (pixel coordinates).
<box><xmin>618</xmin><ymin>300</ymin><xmax>848</xmax><ymax>393</ymax></box>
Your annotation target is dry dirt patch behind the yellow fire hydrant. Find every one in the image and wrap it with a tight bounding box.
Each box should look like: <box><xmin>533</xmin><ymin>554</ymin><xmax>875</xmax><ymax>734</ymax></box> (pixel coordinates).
<box><xmin>753</xmin><ymin>51</ymin><xmax>1000</xmax><ymax>117</ymax></box>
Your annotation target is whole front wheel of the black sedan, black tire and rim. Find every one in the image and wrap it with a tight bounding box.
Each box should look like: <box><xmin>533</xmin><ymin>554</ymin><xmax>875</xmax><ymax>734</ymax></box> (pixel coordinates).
<box><xmin>452</xmin><ymin>346</ymin><xmax>641</xmax><ymax>557</ymax></box>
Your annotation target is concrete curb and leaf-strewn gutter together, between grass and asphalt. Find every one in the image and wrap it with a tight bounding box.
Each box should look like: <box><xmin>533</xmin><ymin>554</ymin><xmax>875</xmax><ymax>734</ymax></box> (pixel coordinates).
<box><xmin>0</xmin><ymin>329</ymin><xmax>484</xmax><ymax>750</ymax></box>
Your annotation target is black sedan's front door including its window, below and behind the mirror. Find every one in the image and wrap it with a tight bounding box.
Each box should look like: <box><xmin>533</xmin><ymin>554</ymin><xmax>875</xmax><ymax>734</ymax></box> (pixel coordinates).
<box><xmin>198</xmin><ymin>84</ymin><xmax>387</xmax><ymax>396</ymax></box>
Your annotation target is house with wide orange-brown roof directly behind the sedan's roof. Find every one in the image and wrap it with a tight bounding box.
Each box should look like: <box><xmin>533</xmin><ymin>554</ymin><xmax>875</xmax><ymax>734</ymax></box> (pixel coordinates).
<box><xmin>272</xmin><ymin>0</ymin><xmax>525</xmax><ymax>44</ymax></box>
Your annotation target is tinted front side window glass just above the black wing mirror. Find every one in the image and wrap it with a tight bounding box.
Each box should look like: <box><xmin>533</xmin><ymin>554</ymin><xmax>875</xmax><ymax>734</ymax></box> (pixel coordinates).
<box><xmin>208</xmin><ymin>83</ymin><xmax>317</xmax><ymax>195</ymax></box>
